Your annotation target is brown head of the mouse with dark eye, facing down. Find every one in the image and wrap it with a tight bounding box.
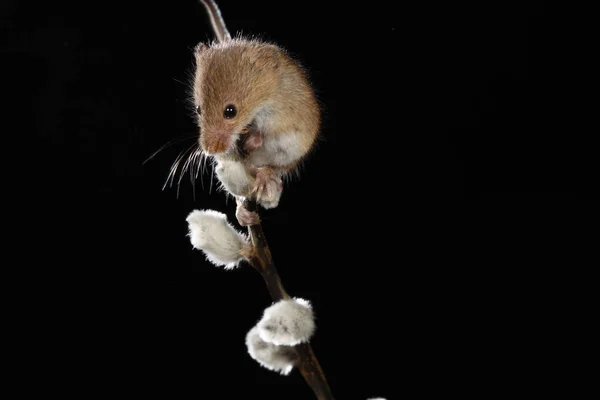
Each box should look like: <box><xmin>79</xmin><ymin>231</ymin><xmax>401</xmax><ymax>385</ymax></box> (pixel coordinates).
<box><xmin>194</xmin><ymin>39</ymin><xmax>280</xmax><ymax>155</ymax></box>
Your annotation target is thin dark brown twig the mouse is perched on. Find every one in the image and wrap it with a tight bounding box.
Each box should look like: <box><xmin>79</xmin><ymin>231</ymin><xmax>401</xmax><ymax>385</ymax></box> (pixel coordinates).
<box><xmin>244</xmin><ymin>198</ymin><xmax>334</xmax><ymax>400</ymax></box>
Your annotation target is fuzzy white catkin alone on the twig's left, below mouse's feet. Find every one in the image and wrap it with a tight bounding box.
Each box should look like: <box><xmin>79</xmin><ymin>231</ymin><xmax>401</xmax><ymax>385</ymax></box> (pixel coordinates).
<box><xmin>186</xmin><ymin>210</ymin><xmax>248</xmax><ymax>269</ymax></box>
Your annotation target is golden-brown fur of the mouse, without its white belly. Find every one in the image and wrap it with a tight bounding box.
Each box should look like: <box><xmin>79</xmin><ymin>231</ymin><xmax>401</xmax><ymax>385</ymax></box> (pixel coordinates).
<box><xmin>194</xmin><ymin>38</ymin><xmax>320</xmax><ymax>170</ymax></box>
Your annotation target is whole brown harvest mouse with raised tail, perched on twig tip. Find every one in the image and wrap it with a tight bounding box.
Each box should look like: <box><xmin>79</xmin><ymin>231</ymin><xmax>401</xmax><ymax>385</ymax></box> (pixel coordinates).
<box><xmin>193</xmin><ymin>0</ymin><xmax>321</xmax><ymax>226</ymax></box>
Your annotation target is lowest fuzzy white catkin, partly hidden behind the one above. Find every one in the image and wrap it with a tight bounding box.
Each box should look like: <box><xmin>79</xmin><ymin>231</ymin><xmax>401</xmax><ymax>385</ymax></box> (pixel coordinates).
<box><xmin>246</xmin><ymin>326</ymin><xmax>297</xmax><ymax>375</ymax></box>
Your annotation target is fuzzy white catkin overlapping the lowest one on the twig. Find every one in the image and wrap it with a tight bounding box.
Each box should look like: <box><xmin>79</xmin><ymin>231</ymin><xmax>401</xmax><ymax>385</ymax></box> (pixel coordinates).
<box><xmin>257</xmin><ymin>298</ymin><xmax>315</xmax><ymax>346</ymax></box>
